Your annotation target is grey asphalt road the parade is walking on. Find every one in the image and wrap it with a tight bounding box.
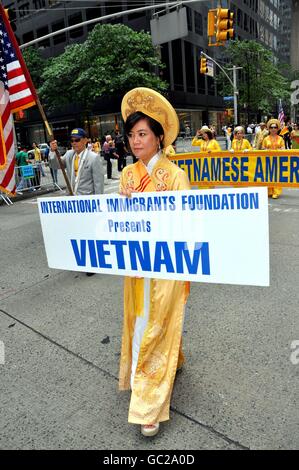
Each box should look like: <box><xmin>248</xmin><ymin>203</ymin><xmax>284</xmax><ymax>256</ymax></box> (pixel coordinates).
<box><xmin>0</xmin><ymin>181</ymin><xmax>299</xmax><ymax>450</ymax></box>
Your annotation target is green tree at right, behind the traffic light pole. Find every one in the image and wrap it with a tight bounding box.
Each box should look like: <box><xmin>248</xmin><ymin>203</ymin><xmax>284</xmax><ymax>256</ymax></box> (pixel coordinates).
<box><xmin>218</xmin><ymin>40</ymin><xmax>290</xmax><ymax>115</ymax></box>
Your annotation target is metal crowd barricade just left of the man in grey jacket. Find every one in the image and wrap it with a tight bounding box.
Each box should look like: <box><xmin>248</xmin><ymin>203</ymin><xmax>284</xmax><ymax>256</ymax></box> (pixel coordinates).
<box><xmin>15</xmin><ymin>162</ymin><xmax>65</xmax><ymax>194</ymax></box>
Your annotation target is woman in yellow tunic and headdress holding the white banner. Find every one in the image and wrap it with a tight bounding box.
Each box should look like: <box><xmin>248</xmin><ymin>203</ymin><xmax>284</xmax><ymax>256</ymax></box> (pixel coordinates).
<box><xmin>119</xmin><ymin>88</ymin><xmax>189</xmax><ymax>436</ymax></box>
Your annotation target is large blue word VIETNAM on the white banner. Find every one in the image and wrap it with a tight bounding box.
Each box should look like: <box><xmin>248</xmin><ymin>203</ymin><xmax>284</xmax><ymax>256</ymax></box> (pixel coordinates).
<box><xmin>71</xmin><ymin>239</ymin><xmax>211</xmax><ymax>276</ymax></box>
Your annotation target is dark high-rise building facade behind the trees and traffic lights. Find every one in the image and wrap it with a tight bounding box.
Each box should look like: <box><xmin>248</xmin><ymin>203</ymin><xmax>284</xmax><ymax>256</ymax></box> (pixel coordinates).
<box><xmin>4</xmin><ymin>0</ymin><xmax>290</xmax><ymax>142</ymax></box>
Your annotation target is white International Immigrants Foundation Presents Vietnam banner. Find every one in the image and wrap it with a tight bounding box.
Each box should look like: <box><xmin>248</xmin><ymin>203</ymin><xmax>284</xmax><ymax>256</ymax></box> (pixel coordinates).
<box><xmin>38</xmin><ymin>187</ymin><xmax>269</xmax><ymax>286</ymax></box>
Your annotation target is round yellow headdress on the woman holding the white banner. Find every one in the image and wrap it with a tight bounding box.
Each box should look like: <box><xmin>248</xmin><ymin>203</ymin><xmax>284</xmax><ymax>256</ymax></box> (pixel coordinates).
<box><xmin>121</xmin><ymin>87</ymin><xmax>180</xmax><ymax>148</ymax></box>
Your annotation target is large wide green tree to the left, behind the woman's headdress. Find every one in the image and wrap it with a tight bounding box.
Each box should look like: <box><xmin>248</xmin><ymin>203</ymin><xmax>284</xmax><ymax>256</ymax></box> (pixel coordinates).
<box><xmin>40</xmin><ymin>25</ymin><xmax>168</xmax><ymax>110</ymax></box>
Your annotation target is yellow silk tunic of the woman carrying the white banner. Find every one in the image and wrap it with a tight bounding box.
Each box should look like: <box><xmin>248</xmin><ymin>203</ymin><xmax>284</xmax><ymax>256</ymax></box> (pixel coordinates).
<box><xmin>119</xmin><ymin>156</ymin><xmax>190</xmax><ymax>424</ymax></box>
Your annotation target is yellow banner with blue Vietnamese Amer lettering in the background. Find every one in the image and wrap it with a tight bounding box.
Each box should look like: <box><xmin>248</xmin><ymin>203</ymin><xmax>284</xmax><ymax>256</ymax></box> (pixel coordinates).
<box><xmin>171</xmin><ymin>150</ymin><xmax>299</xmax><ymax>188</ymax></box>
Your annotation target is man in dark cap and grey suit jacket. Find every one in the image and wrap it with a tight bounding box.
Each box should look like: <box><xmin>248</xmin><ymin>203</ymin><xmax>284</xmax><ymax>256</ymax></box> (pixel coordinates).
<box><xmin>50</xmin><ymin>127</ymin><xmax>104</xmax><ymax>195</ymax></box>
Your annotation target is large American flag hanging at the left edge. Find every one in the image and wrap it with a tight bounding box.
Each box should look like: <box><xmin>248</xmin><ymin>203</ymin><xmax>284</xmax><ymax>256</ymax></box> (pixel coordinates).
<box><xmin>0</xmin><ymin>4</ymin><xmax>36</xmax><ymax>195</ymax></box>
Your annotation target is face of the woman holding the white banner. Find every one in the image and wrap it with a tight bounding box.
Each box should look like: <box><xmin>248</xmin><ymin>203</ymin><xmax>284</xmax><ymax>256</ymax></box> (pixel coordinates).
<box><xmin>128</xmin><ymin>119</ymin><xmax>162</xmax><ymax>165</ymax></box>
